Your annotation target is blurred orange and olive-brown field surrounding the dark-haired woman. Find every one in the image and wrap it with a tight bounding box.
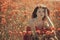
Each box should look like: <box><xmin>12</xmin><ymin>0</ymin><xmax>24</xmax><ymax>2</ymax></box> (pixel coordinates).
<box><xmin>0</xmin><ymin>0</ymin><xmax>60</xmax><ymax>40</ymax></box>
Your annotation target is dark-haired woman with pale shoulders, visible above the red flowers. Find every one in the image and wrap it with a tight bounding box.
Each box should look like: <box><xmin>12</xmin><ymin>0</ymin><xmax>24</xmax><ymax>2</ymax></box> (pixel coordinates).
<box><xmin>29</xmin><ymin>6</ymin><xmax>49</xmax><ymax>34</ymax></box>
